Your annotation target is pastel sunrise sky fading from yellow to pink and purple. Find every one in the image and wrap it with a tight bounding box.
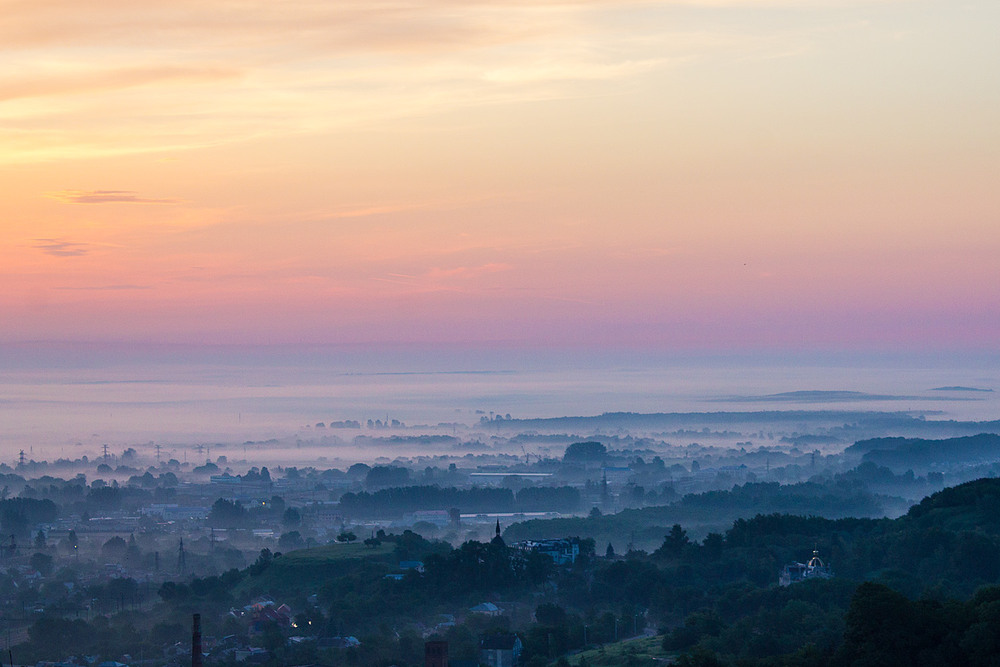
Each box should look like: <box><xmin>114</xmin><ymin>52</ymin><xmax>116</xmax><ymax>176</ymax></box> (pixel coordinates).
<box><xmin>0</xmin><ymin>0</ymin><xmax>1000</xmax><ymax>350</ymax></box>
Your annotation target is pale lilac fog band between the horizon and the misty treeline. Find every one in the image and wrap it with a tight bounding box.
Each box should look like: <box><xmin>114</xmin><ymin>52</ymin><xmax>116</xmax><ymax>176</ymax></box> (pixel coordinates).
<box><xmin>0</xmin><ymin>346</ymin><xmax>1000</xmax><ymax>465</ymax></box>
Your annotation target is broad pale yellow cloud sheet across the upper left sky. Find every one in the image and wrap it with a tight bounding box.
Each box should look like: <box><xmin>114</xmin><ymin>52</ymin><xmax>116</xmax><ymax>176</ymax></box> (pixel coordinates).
<box><xmin>0</xmin><ymin>0</ymin><xmax>844</xmax><ymax>164</ymax></box>
